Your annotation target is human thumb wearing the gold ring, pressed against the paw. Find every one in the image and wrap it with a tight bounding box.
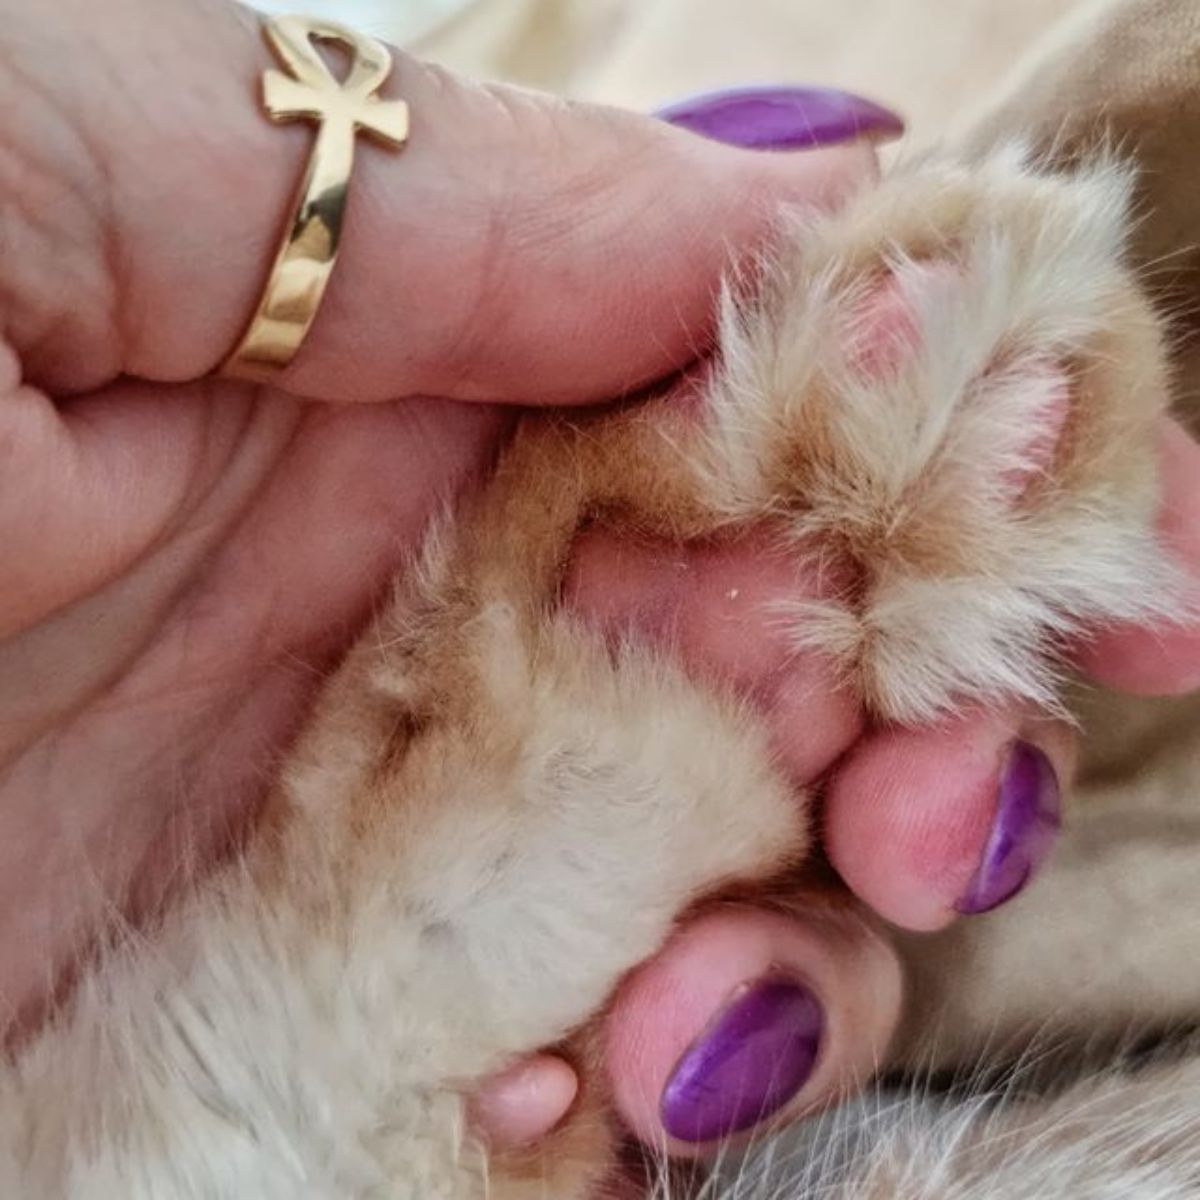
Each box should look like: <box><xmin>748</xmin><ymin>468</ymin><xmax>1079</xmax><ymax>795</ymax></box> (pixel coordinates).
<box><xmin>7</xmin><ymin>0</ymin><xmax>887</xmax><ymax>402</ymax></box>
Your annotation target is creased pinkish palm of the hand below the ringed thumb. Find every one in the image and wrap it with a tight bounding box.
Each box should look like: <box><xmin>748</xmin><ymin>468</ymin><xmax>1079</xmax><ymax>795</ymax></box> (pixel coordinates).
<box><xmin>0</xmin><ymin>372</ymin><xmax>503</xmax><ymax>1003</ymax></box>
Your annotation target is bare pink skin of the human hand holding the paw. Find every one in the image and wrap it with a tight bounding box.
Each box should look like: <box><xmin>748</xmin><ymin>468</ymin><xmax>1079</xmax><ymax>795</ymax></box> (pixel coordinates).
<box><xmin>0</xmin><ymin>0</ymin><xmax>1200</xmax><ymax>1161</ymax></box>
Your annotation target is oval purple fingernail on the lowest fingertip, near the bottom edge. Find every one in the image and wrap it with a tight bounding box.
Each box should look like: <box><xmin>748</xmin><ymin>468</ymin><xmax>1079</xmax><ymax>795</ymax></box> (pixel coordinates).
<box><xmin>661</xmin><ymin>978</ymin><xmax>824</xmax><ymax>1141</ymax></box>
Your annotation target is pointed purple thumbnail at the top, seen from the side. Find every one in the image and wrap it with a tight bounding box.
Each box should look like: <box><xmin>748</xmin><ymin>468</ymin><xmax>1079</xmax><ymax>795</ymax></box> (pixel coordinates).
<box><xmin>656</xmin><ymin>86</ymin><xmax>904</xmax><ymax>150</ymax></box>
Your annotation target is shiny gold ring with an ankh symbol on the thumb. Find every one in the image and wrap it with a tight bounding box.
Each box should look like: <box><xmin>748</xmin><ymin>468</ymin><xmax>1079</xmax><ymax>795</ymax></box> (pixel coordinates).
<box><xmin>221</xmin><ymin>17</ymin><xmax>408</xmax><ymax>380</ymax></box>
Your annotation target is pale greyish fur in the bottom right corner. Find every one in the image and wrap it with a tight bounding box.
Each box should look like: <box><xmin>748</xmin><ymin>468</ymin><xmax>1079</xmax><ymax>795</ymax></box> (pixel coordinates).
<box><xmin>705</xmin><ymin>1057</ymin><xmax>1200</xmax><ymax>1200</ymax></box>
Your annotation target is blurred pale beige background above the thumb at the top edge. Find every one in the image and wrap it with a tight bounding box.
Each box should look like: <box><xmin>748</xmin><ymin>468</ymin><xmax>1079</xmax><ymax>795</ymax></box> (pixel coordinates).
<box><xmin>260</xmin><ymin>0</ymin><xmax>1080</xmax><ymax>132</ymax></box>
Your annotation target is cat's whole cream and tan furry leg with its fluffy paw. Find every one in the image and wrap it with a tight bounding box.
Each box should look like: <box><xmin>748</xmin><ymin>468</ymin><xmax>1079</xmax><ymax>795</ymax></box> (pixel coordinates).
<box><xmin>0</xmin><ymin>119</ymin><xmax>1177</xmax><ymax>1200</ymax></box>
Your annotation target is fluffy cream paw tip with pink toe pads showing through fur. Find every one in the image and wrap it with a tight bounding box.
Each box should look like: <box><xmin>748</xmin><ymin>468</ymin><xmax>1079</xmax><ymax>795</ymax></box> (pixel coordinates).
<box><xmin>700</xmin><ymin>140</ymin><xmax>1180</xmax><ymax>721</ymax></box>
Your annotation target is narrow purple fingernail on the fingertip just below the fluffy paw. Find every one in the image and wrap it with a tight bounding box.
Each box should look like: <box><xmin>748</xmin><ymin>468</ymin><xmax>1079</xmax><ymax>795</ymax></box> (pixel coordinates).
<box><xmin>955</xmin><ymin>742</ymin><xmax>1061</xmax><ymax>916</ymax></box>
